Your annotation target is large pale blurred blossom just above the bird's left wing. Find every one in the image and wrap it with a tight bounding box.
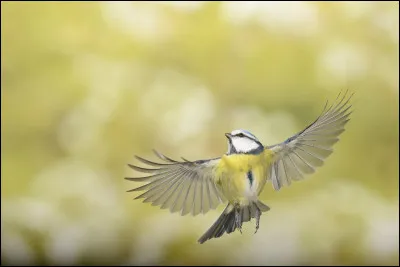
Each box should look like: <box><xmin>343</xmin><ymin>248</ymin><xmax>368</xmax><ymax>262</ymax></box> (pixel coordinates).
<box><xmin>140</xmin><ymin>70</ymin><xmax>215</xmax><ymax>149</ymax></box>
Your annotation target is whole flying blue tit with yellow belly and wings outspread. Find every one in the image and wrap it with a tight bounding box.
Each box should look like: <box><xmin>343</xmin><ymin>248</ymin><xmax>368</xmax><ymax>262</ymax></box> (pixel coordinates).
<box><xmin>125</xmin><ymin>90</ymin><xmax>353</xmax><ymax>244</ymax></box>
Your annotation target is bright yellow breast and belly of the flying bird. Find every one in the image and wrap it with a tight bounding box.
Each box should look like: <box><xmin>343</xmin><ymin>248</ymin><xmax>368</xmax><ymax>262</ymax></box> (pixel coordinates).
<box><xmin>217</xmin><ymin>151</ymin><xmax>272</xmax><ymax>204</ymax></box>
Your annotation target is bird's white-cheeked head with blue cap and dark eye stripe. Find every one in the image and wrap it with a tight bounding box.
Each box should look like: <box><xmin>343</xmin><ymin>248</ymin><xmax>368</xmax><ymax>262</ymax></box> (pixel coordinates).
<box><xmin>225</xmin><ymin>130</ymin><xmax>264</xmax><ymax>154</ymax></box>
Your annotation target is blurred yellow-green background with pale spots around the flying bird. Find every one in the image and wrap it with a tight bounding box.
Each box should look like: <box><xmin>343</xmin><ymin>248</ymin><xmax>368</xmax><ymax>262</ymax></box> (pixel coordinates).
<box><xmin>1</xmin><ymin>1</ymin><xmax>399</xmax><ymax>265</ymax></box>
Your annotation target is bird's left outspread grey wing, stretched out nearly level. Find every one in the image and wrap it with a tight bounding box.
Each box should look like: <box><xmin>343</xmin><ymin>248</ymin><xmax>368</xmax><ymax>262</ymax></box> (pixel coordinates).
<box><xmin>125</xmin><ymin>150</ymin><xmax>226</xmax><ymax>218</ymax></box>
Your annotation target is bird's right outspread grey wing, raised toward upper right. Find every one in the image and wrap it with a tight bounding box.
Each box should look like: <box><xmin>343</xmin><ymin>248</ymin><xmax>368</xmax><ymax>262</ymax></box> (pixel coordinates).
<box><xmin>266</xmin><ymin>92</ymin><xmax>353</xmax><ymax>190</ymax></box>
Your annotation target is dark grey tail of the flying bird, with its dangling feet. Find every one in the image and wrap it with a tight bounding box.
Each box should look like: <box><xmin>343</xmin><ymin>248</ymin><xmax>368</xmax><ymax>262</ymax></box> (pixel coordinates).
<box><xmin>198</xmin><ymin>200</ymin><xmax>270</xmax><ymax>244</ymax></box>
